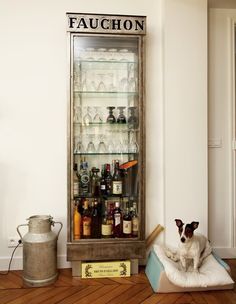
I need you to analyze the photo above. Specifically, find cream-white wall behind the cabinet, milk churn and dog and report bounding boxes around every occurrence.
[0,0,207,269]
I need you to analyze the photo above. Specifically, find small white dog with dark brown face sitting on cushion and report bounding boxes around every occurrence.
[167,219,212,272]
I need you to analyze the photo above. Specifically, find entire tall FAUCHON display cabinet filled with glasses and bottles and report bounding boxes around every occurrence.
[67,13,146,275]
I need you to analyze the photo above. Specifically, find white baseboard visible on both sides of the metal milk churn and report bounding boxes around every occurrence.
[0,255,71,271]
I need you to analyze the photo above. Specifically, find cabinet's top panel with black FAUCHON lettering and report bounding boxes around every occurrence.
[67,13,146,35]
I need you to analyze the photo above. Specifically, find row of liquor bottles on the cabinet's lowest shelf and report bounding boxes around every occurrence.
[73,198,139,240]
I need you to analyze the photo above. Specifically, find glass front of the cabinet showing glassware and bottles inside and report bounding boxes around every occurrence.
[70,34,143,242]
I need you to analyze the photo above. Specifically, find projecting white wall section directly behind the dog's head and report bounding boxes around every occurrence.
[164,0,208,244]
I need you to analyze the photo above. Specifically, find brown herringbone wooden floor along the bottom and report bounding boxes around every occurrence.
[0,260,236,304]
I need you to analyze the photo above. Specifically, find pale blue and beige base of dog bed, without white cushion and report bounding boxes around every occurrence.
[145,249,234,293]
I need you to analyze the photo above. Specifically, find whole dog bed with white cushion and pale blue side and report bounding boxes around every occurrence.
[145,245,234,293]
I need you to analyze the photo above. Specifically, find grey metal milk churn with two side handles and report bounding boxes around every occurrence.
[17,215,63,287]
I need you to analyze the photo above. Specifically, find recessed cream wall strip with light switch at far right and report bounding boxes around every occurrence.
[209,9,236,257]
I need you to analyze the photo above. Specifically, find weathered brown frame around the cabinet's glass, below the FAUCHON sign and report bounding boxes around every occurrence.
[67,14,146,268]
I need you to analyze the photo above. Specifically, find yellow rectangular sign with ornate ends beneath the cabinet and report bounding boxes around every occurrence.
[82,261,130,279]
